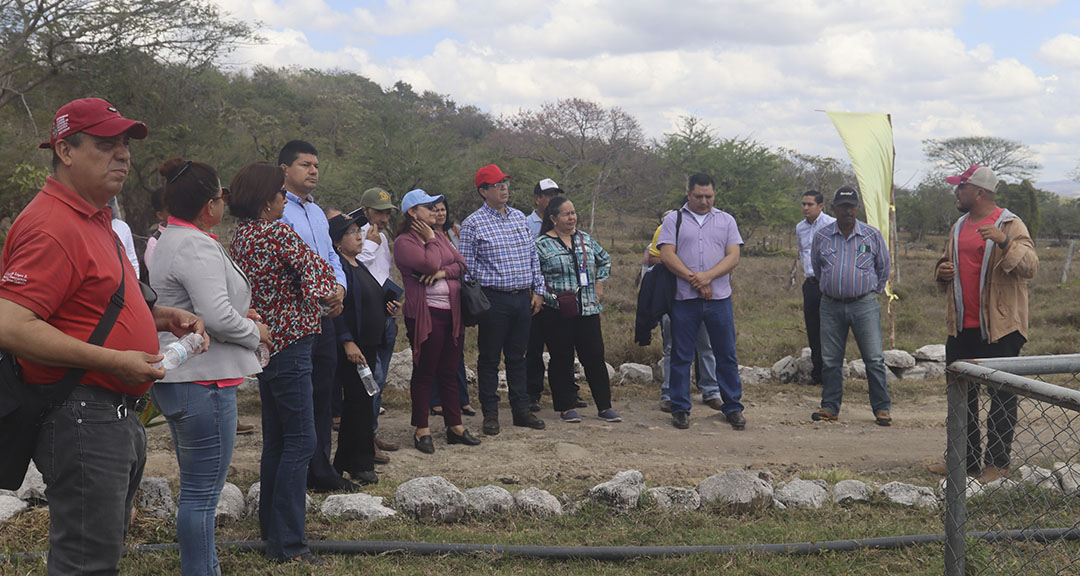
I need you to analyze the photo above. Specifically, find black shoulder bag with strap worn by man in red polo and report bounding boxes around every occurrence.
[0,235,126,490]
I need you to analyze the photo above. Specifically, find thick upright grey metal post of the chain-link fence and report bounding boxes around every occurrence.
[945,373,968,576]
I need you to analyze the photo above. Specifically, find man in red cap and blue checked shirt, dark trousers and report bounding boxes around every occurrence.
[459,164,544,436]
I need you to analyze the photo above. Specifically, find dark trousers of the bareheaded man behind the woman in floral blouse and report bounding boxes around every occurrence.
[308,318,341,485]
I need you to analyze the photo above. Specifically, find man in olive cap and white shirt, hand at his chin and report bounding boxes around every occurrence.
[356,188,399,464]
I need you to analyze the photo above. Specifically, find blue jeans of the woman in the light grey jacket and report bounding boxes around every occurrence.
[150,383,237,576]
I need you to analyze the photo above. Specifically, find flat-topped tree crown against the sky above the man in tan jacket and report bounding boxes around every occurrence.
[922,136,1042,180]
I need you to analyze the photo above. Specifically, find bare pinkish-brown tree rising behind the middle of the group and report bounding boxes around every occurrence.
[501,98,645,231]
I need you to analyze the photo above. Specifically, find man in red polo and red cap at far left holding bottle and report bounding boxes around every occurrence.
[0,98,205,574]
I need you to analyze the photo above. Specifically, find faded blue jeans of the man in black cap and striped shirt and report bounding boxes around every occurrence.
[821,292,892,414]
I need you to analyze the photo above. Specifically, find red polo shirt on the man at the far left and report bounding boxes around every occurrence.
[0,177,158,396]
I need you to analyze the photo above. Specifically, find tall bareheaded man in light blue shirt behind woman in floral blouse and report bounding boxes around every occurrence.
[278,140,360,492]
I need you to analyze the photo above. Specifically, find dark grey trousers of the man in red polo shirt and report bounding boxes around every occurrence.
[33,385,146,575]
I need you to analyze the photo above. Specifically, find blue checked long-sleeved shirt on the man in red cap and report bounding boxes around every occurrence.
[458,202,545,296]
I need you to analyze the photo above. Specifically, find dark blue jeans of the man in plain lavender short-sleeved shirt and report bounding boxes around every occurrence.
[669,298,743,414]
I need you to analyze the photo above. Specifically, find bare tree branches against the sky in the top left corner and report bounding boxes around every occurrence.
[0,0,259,106]
